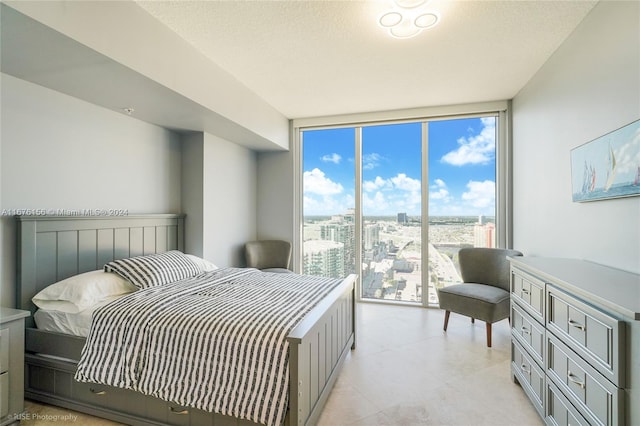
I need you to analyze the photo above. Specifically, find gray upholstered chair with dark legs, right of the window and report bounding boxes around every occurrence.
[437,247,522,347]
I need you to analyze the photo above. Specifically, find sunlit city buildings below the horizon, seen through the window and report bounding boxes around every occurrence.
[303,212,495,304]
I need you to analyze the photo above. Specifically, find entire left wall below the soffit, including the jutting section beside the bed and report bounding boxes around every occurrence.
[0,74,257,307]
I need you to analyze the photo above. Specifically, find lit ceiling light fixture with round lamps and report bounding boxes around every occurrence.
[378,0,440,38]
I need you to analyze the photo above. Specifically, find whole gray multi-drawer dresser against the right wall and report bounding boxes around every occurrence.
[510,257,640,425]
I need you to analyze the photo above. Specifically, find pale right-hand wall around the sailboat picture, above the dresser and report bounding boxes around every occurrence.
[513,1,640,272]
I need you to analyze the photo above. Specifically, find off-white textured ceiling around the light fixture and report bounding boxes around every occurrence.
[138,0,597,118]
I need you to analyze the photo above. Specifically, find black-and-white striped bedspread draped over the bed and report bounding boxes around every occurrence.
[75,268,341,425]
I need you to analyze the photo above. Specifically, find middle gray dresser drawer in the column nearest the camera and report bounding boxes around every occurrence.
[546,333,624,426]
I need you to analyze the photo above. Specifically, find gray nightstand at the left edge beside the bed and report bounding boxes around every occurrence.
[0,308,31,426]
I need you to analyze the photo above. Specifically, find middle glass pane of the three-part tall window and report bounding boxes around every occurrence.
[361,123,422,303]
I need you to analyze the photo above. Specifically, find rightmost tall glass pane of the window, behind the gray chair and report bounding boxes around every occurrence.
[428,117,497,304]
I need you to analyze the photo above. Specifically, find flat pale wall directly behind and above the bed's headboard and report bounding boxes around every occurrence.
[0,74,181,307]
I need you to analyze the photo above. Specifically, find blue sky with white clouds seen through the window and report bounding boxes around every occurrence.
[302,117,496,216]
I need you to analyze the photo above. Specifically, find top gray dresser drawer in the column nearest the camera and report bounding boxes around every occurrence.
[547,285,625,387]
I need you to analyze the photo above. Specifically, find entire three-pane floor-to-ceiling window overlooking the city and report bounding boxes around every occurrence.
[297,105,506,305]
